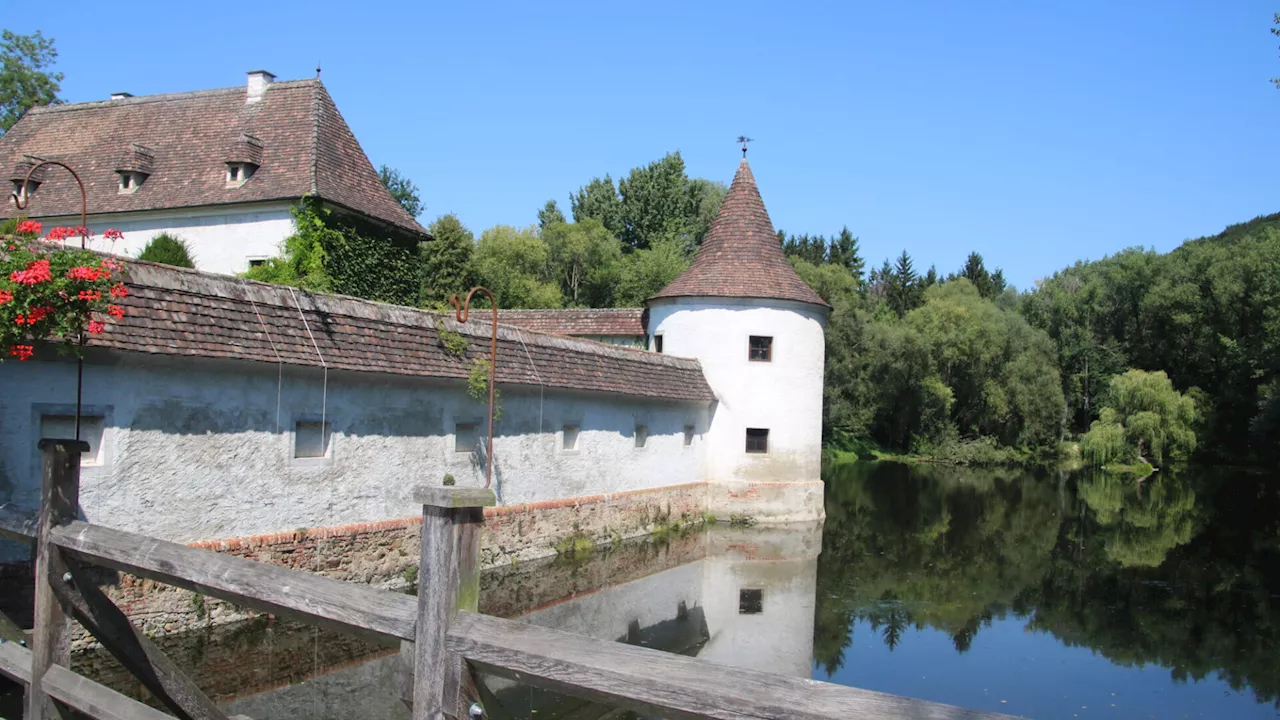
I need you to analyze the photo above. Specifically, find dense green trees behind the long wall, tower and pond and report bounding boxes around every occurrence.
[241,152,1280,465]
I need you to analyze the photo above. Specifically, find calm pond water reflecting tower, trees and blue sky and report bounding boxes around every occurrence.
[15,464,1280,720]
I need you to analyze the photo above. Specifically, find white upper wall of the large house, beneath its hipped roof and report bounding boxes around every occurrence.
[41,202,293,274]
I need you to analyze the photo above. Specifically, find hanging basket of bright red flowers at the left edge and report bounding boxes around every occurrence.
[0,220,129,361]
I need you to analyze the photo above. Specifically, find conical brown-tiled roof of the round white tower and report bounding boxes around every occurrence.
[650,158,831,307]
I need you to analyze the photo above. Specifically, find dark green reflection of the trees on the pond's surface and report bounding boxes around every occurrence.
[814,464,1280,701]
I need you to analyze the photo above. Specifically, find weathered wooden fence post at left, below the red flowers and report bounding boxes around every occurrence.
[26,439,88,720]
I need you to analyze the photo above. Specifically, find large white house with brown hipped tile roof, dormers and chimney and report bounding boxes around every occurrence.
[0,70,428,274]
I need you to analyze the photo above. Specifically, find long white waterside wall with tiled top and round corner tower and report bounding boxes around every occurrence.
[0,155,828,560]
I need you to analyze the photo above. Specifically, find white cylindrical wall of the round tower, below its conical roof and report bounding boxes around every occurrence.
[649,297,827,482]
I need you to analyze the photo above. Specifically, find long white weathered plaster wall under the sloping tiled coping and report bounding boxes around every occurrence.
[0,354,708,561]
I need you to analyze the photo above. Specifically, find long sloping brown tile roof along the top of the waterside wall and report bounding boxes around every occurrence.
[88,260,716,402]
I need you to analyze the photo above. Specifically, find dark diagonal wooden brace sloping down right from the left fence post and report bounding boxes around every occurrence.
[49,560,227,720]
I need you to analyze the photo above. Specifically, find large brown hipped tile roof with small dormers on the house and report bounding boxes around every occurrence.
[0,79,426,234]
